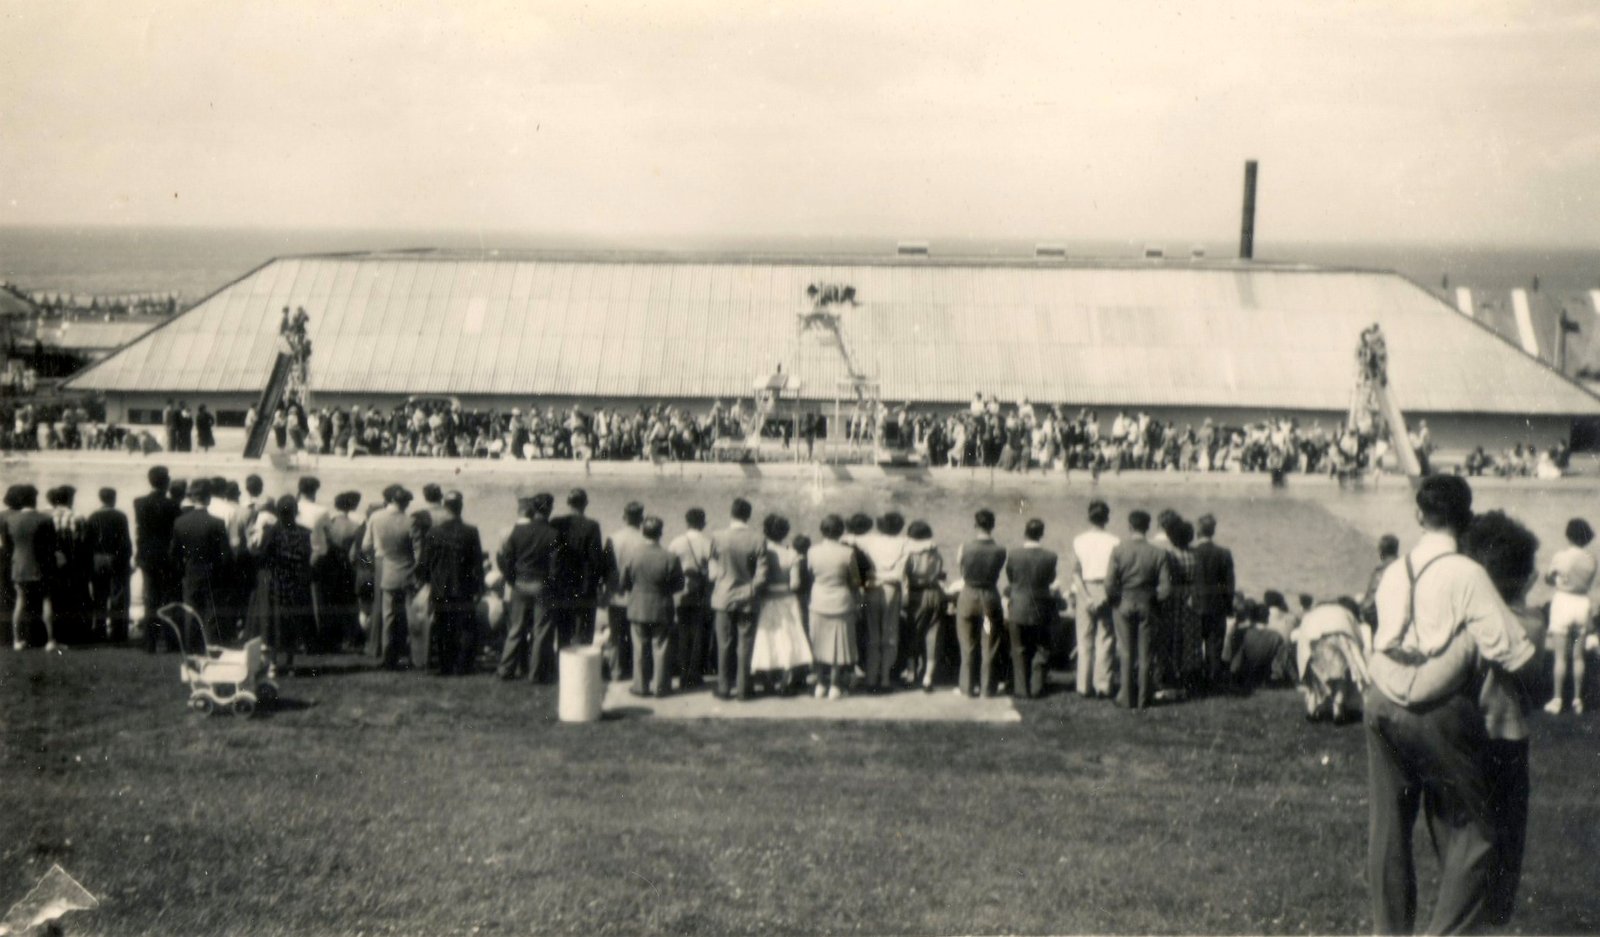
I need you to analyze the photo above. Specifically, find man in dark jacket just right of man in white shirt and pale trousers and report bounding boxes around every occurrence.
[1106,510,1173,710]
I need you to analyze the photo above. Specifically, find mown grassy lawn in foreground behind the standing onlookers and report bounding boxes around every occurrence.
[0,649,1600,934]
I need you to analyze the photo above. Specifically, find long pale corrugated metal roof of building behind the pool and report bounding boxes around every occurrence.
[59,253,1600,414]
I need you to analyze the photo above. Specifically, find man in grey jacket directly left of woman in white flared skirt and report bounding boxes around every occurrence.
[710,497,766,700]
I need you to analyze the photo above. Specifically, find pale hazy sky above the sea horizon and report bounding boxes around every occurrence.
[0,0,1600,246]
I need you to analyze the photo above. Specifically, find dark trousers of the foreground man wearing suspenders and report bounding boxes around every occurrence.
[1365,689,1494,934]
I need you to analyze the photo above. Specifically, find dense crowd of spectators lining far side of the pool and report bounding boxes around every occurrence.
[0,386,1571,478]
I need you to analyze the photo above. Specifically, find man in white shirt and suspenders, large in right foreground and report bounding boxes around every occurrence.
[1365,475,1536,934]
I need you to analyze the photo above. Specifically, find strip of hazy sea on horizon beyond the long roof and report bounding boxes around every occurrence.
[0,227,1600,302]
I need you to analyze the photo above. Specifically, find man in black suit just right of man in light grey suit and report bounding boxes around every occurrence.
[418,491,483,676]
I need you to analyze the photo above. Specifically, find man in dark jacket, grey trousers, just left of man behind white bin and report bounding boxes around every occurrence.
[496,492,555,683]
